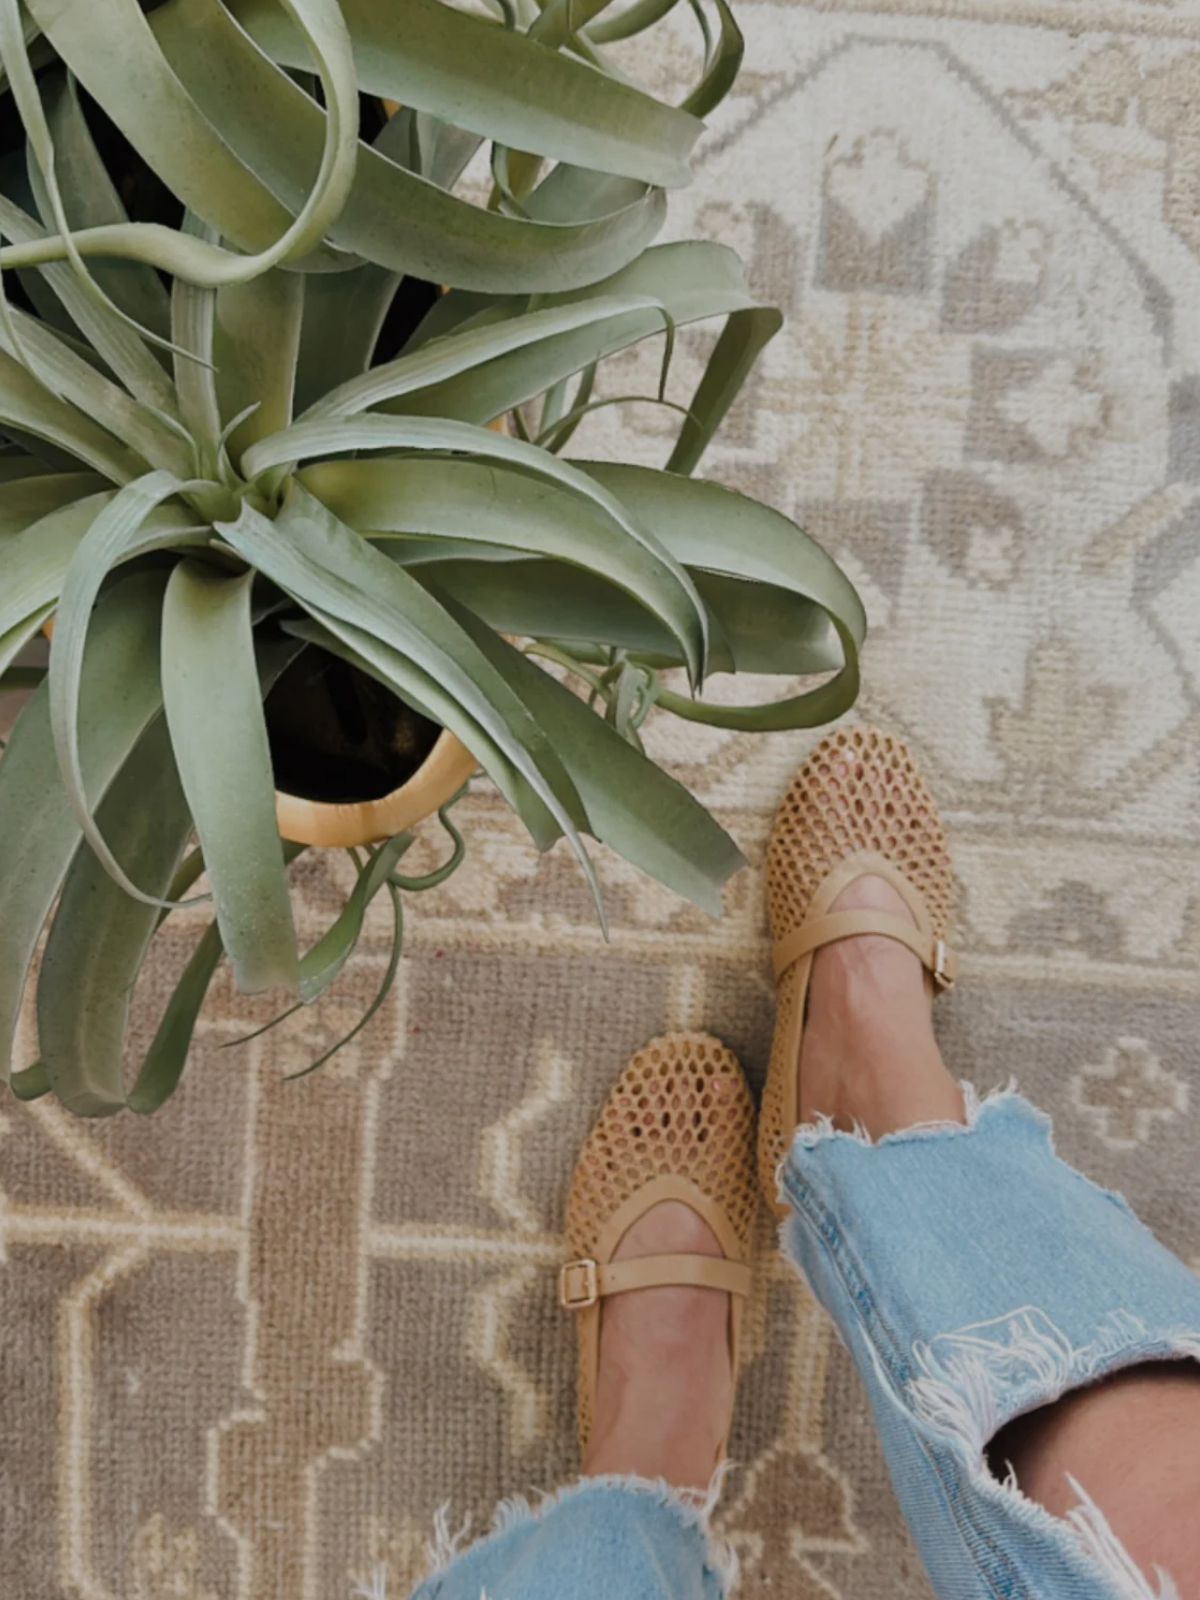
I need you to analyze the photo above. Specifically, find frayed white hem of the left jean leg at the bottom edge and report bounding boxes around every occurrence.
[350,1461,738,1600]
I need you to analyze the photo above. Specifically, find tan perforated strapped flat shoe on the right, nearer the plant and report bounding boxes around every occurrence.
[758,728,958,1216]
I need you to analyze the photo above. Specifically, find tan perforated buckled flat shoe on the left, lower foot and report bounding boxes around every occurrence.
[558,1034,758,1459]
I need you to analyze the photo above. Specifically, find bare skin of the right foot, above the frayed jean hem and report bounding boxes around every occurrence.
[800,877,965,1139]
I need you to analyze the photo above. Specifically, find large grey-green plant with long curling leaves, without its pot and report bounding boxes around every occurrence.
[0,0,864,1115]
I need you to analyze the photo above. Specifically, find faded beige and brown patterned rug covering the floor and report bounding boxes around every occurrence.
[0,0,1200,1600]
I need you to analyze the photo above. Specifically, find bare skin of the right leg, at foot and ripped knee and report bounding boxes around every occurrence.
[800,878,1200,1592]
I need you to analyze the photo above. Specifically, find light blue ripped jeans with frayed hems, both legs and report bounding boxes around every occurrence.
[392,1085,1200,1600]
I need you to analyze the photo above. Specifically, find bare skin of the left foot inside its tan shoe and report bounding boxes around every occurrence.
[584,1078,733,1488]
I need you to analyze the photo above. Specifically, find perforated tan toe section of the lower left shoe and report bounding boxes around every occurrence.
[566,1034,758,1256]
